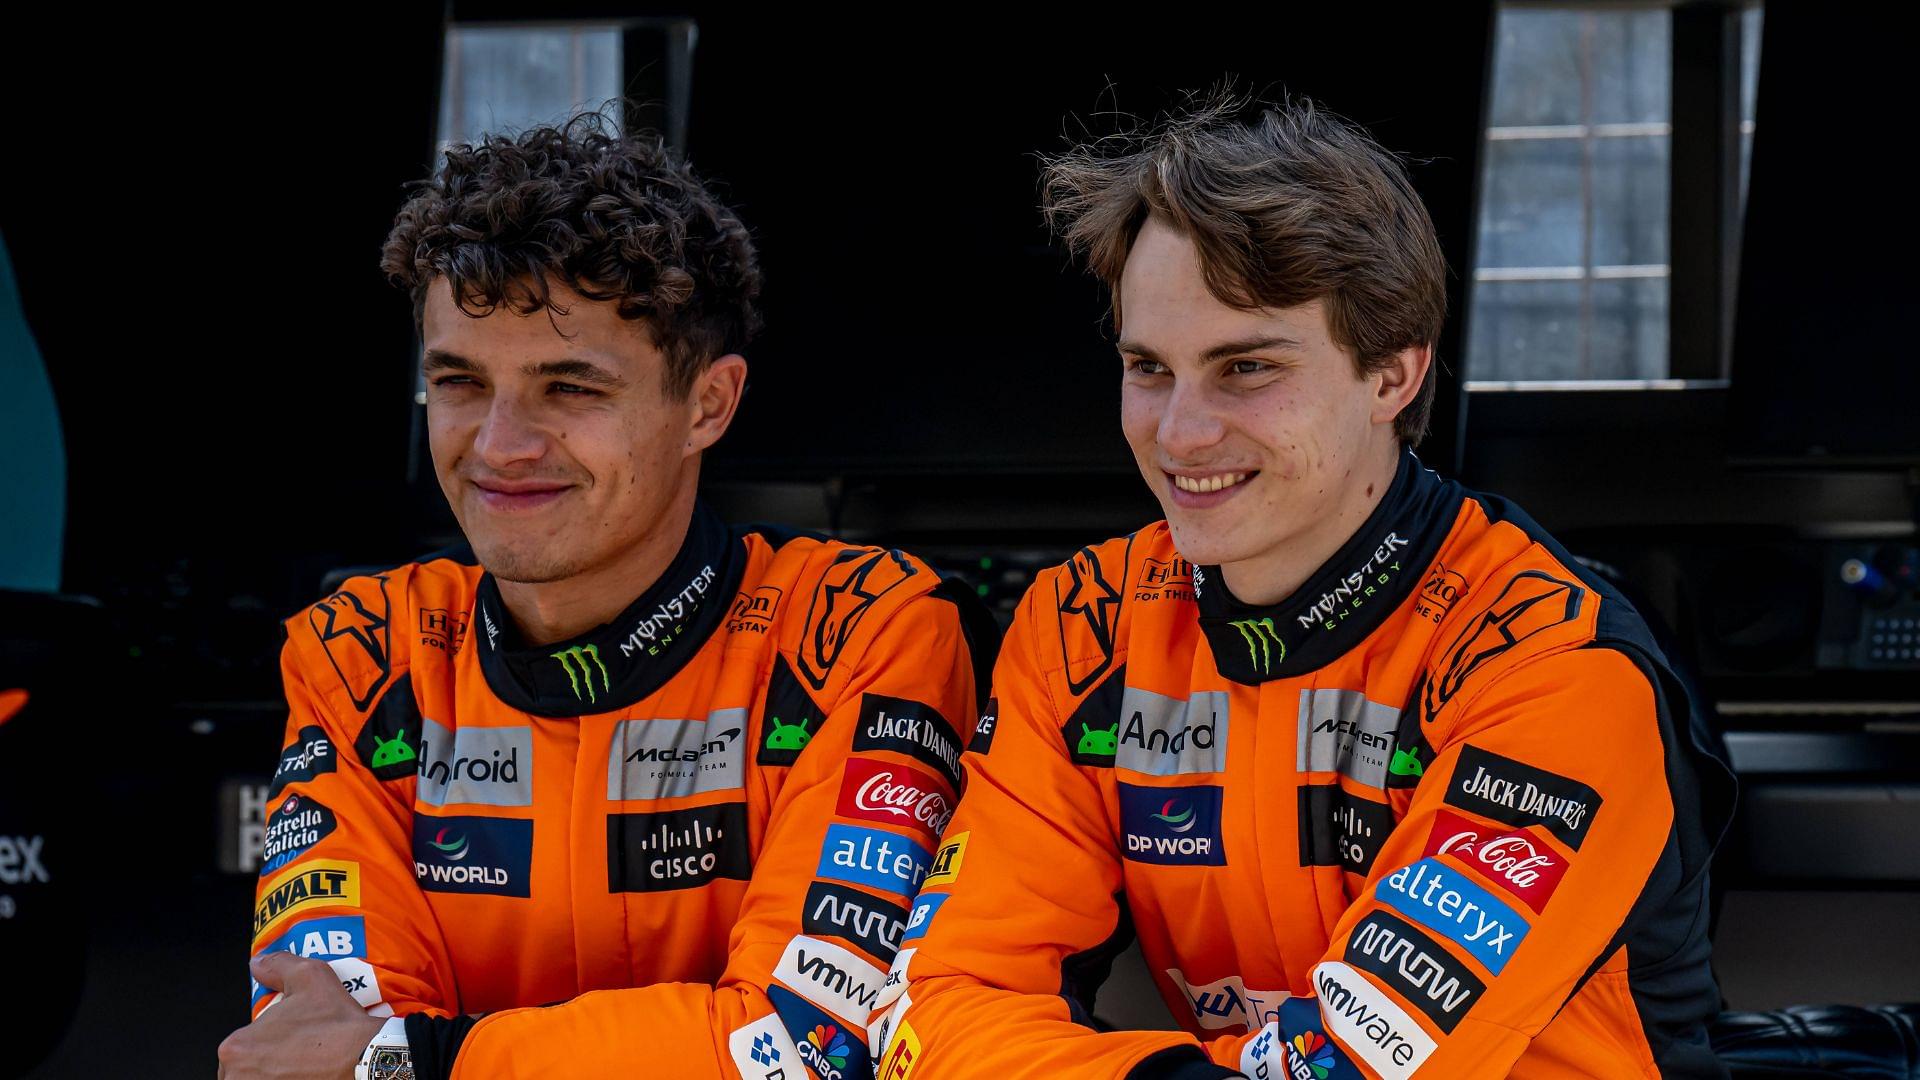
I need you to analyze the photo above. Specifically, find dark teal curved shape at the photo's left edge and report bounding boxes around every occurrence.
[0,232,67,592]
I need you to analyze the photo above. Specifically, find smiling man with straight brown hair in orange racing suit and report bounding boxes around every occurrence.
[874,100,1732,1080]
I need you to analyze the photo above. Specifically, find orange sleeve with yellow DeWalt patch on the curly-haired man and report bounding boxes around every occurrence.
[252,578,459,1017]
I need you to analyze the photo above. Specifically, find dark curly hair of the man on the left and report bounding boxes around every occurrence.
[380,113,760,398]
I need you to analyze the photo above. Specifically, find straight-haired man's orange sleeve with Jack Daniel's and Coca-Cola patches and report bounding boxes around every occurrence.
[1210,648,1678,1080]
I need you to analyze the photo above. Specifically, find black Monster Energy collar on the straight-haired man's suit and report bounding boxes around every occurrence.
[1194,452,1459,684]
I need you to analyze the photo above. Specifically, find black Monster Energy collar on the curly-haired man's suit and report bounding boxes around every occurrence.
[472,503,747,717]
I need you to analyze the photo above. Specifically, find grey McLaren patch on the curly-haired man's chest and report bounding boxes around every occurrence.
[607,709,747,801]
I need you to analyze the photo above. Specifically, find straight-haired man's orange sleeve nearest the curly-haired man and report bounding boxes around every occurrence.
[876,578,1227,1080]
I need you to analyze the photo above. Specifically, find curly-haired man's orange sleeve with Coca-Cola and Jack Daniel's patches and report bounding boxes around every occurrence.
[451,596,977,1080]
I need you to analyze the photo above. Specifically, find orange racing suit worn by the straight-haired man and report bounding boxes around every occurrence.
[872,454,1732,1080]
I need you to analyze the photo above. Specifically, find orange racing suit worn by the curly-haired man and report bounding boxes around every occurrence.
[253,507,991,1080]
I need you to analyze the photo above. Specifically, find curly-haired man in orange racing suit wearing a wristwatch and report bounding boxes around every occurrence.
[221,115,991,1080]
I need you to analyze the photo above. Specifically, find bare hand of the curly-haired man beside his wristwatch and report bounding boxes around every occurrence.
[219,951,386,1080]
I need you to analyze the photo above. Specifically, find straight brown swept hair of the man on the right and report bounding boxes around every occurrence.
[1043,86,1446,446]
